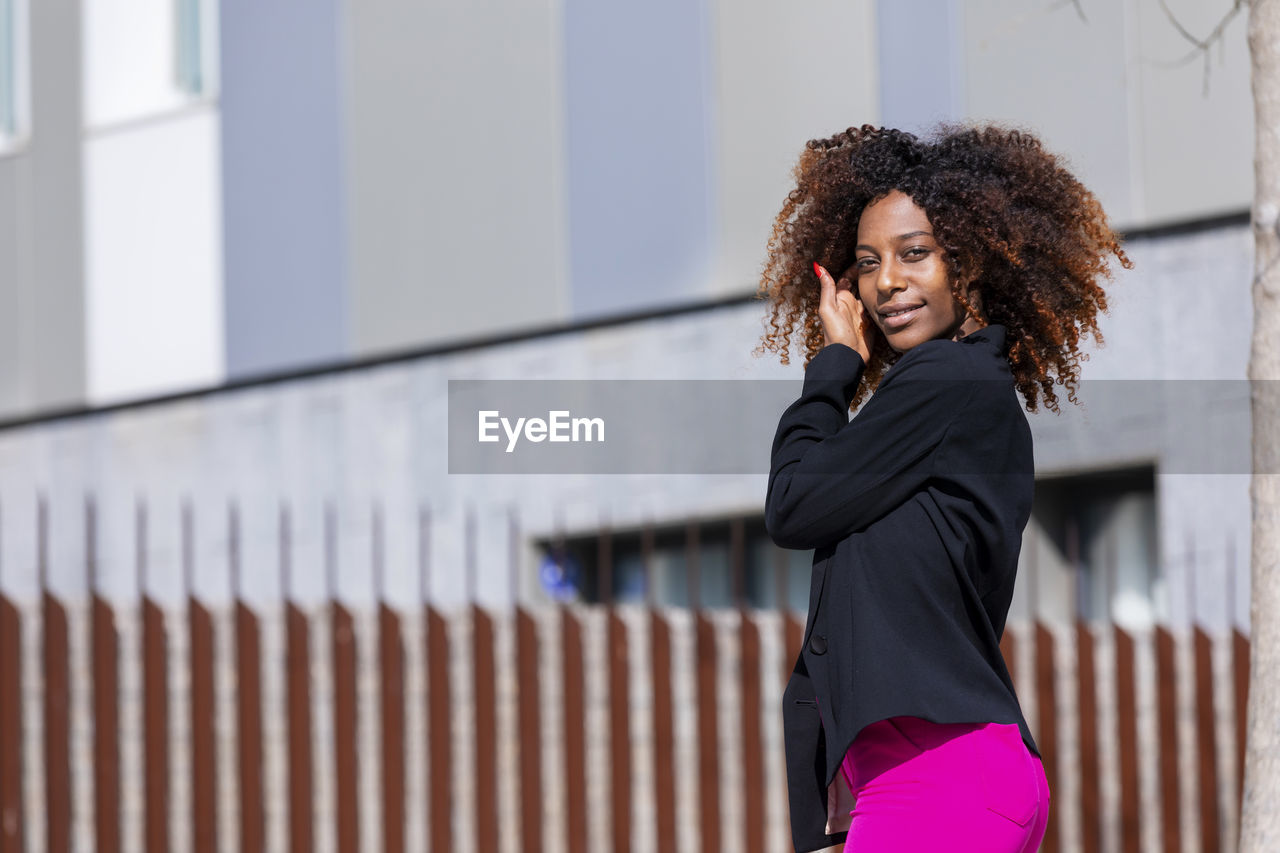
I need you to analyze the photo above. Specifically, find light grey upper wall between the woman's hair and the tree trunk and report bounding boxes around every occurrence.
[961,0,1253,228]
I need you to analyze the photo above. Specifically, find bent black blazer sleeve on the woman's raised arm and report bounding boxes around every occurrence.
[764,341,973,549]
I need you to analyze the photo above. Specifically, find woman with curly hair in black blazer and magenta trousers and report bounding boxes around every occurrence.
[758,126,1132,853]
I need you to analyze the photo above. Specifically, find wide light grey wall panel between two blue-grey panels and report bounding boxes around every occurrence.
[344,0,568,355]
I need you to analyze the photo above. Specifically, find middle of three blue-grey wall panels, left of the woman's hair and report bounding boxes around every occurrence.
[564,0,718,319]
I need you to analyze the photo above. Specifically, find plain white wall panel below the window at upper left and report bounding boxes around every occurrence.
[84,109,225,405]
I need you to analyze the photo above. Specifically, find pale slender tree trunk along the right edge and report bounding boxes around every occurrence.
[1239,0,1280,853]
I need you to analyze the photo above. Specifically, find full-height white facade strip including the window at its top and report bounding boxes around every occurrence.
[82,0,225,406]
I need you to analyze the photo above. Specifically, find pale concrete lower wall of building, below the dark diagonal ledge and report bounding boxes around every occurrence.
[0,227,1249,635]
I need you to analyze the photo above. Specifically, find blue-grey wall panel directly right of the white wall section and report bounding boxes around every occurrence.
[220,0,347,379]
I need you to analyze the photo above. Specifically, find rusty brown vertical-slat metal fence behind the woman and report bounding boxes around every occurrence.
[0,494,1249,853]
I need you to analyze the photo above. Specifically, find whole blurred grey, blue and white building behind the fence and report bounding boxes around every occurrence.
[0,0,1252,624]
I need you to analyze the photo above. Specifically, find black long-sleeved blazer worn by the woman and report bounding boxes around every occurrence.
[765,324,1039,853]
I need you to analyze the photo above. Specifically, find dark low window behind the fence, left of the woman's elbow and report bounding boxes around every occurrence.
[539,516,813,612]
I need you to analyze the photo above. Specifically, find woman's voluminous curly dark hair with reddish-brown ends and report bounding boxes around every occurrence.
[755,124,1133,411]
